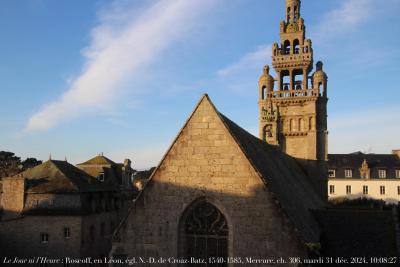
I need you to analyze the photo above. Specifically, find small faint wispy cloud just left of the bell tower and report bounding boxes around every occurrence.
[217,45,272,77]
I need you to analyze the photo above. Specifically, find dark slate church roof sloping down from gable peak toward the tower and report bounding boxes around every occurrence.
[115,94,324,245]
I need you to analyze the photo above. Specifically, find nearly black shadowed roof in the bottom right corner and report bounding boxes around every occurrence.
[314,208,397,260]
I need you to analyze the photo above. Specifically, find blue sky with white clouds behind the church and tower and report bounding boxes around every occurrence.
[0,0,400,168]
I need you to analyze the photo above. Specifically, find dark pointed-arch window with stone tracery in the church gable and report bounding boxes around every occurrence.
[178,200,229,266]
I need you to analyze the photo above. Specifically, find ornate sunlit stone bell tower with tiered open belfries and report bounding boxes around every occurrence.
[258,0,328,199]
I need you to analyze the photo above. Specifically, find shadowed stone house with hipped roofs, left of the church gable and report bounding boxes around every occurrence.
[0,156,133,263]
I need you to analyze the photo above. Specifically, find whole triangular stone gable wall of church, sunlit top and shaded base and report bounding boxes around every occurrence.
[111,95,316,257]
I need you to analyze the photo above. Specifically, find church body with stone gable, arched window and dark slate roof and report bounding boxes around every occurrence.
[112,95,323,266]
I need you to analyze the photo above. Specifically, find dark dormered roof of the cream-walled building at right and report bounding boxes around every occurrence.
[328,152,400,169]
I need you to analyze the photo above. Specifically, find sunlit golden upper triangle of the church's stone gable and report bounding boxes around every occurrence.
[151,95,263,197]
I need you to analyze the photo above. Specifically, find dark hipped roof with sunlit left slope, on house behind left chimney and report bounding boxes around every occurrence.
[21,160,110,193]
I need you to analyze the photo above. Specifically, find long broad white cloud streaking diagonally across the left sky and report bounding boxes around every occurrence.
[25,0,212,131]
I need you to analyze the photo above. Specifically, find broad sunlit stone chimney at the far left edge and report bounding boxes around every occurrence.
[0,176,25,219]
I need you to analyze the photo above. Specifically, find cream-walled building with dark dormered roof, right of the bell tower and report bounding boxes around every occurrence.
[328,150,400,203]
